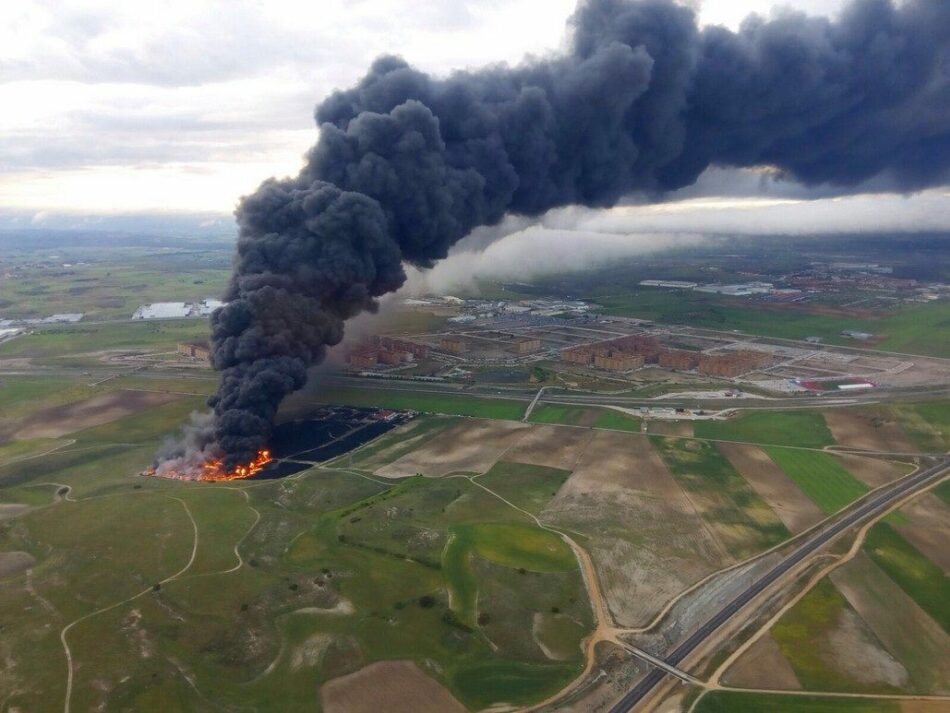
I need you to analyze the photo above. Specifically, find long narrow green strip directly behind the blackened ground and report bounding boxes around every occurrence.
[313,387,528,421]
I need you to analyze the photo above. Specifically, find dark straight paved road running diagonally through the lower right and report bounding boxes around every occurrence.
[610,459,950,713]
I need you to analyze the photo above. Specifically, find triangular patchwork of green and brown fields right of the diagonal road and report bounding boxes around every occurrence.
[714,470,950,710]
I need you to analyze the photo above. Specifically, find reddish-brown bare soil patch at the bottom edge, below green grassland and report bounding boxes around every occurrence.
[320,661,465,713]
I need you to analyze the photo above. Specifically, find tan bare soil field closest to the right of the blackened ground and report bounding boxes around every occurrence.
[375,419,530,478]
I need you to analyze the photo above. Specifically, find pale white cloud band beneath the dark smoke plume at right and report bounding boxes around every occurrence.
[408,189,950,296]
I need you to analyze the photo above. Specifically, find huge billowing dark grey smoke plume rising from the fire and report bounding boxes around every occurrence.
[190,0,950,465]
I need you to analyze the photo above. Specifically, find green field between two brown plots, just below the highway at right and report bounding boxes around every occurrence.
[693,411,834,448]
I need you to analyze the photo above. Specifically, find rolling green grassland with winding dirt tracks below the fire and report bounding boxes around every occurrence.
[0,356,592,713]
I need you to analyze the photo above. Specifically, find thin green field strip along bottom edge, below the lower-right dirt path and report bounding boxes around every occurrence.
[693,691,901,713]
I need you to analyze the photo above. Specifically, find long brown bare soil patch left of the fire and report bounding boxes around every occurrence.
[14,391,181,438]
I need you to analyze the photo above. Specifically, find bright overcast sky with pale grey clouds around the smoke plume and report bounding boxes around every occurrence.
[0,0,950,245]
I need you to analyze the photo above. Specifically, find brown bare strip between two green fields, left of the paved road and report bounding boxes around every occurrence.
[716,443,824,533]
